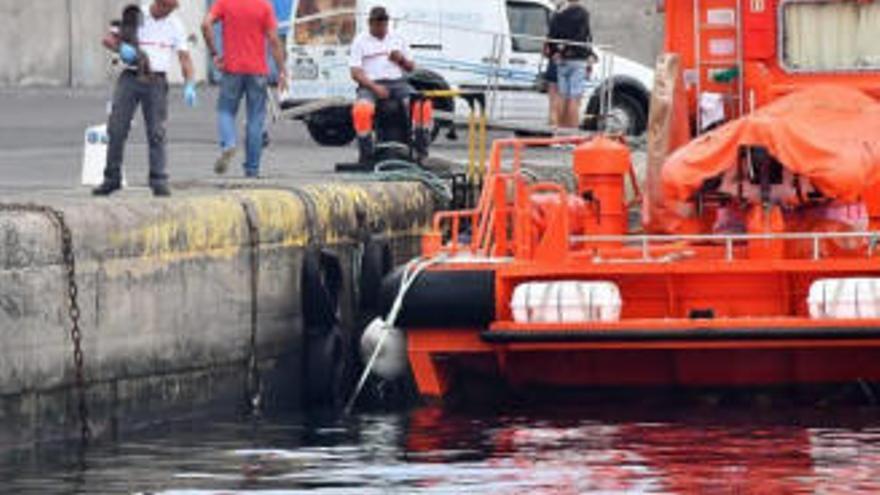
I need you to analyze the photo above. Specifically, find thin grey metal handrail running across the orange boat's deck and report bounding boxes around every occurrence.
[569,231,880,261]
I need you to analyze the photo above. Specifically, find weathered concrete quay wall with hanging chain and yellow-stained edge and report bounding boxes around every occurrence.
[0,183,433,448]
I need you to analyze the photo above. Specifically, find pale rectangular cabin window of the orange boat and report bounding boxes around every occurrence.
[781,0,880,72]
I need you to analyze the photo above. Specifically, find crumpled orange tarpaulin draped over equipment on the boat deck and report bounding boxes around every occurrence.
[663,85,880,204]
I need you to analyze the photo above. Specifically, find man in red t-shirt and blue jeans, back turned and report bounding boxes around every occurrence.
[202,0,287,177]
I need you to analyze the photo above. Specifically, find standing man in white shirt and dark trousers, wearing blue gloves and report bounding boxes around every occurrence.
[92,0,196,196]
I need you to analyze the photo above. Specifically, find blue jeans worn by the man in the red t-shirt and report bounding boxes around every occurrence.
[217,73,267,175]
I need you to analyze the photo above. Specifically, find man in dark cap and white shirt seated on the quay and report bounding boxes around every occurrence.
[349,7,415,161]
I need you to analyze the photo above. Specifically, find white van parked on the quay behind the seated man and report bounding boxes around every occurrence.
[285,0,654,145]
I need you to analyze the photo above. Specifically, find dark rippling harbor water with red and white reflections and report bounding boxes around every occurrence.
[0,401,880,495]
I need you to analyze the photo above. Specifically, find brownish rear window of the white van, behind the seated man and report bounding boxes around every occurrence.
[294,0,357,45]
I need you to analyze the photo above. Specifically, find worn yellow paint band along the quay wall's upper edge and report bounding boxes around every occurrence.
[109,183,428,266]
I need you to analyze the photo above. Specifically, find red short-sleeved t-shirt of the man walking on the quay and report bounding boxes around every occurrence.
[211,0,278,75]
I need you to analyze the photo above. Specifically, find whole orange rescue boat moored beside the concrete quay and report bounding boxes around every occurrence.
[386,0,880,397]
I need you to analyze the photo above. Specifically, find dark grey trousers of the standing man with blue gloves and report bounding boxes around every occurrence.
[104,71,168,186]
